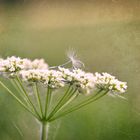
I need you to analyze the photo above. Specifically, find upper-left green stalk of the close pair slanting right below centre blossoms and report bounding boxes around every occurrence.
[47,86,73,120]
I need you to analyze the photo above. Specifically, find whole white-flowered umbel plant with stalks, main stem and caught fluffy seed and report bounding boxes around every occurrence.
[0,54,127,140]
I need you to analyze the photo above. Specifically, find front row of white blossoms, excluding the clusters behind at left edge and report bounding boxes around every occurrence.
[19,67,127,94]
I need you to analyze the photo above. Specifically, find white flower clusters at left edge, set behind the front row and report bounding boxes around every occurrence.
[0,56,48,75]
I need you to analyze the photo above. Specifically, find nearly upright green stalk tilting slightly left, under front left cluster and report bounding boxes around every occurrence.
[35,83,43,117]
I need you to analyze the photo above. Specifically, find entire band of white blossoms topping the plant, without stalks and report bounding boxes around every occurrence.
[0,56,127,93]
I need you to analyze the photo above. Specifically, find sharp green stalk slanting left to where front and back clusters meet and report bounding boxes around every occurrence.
[16,76,41,119]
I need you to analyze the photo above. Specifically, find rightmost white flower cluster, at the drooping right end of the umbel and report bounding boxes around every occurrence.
[95,72,127,93]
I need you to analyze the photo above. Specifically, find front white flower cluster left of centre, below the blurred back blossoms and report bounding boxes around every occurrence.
[19,69,64,88]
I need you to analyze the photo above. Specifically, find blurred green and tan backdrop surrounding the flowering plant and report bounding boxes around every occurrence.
[0,0,140,140]
